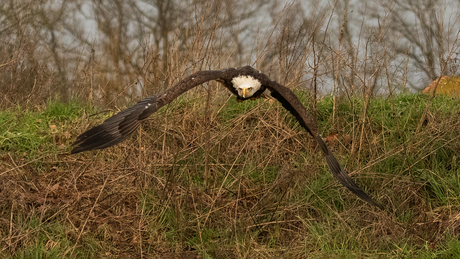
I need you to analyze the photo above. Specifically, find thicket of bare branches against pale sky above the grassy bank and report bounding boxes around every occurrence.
[0,0,460,107]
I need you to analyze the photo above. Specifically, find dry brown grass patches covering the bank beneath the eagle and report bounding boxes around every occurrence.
[0,94,460,258]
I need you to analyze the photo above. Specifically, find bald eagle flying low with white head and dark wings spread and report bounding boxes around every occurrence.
[71,66,383,209]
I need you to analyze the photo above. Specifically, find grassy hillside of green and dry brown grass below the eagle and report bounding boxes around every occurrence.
[0,92,460,258]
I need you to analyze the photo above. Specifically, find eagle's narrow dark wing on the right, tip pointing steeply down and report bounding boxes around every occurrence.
[262,78,383,210]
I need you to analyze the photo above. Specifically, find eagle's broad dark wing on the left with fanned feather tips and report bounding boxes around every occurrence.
[71,70,225,154]
